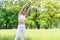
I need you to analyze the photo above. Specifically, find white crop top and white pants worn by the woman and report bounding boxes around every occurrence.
[14,15,25,40]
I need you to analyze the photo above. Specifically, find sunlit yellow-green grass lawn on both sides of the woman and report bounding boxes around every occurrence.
[0,29,60,40]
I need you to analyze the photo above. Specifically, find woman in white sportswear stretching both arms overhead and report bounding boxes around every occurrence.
[14,3,31,40]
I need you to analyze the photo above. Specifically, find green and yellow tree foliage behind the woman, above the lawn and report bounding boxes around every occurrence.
[0,0,60,29]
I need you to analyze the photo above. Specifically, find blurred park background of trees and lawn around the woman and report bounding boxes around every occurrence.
[0,0,60,40]
